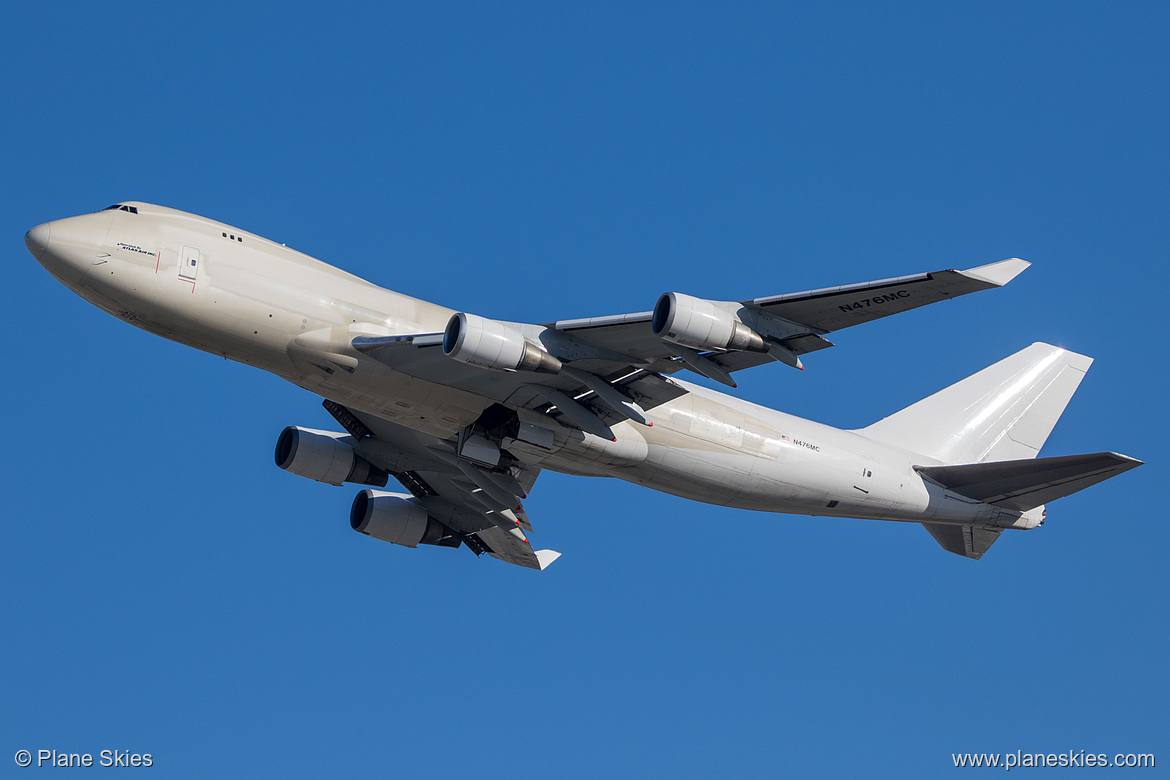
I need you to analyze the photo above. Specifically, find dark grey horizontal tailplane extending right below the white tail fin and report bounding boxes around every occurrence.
[915,453,1142,512]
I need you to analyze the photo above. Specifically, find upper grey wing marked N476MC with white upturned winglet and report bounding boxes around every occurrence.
[351,258,1028,439]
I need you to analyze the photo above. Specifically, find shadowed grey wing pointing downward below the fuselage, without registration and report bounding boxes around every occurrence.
[324,400,560,570]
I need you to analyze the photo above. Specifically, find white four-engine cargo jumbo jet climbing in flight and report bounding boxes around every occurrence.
[25,201,1141,570]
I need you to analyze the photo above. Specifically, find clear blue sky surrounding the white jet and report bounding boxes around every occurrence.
[0,2,1170,778]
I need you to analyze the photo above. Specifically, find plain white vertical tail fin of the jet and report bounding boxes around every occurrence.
[860,344,1093,463]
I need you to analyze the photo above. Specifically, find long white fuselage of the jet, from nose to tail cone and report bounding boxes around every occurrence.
[27,203,1035,537]
